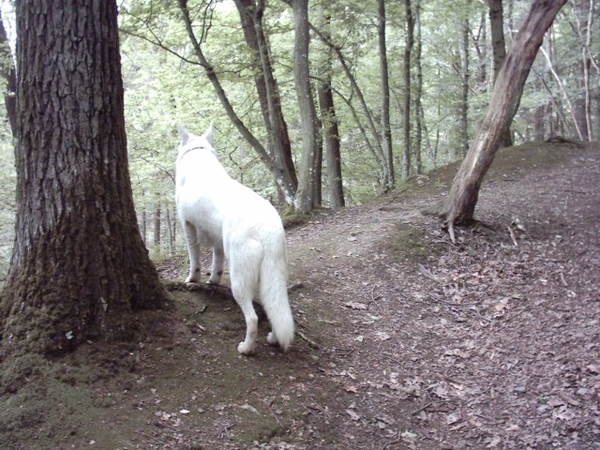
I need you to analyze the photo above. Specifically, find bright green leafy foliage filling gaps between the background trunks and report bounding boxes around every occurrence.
[0,0,600,260]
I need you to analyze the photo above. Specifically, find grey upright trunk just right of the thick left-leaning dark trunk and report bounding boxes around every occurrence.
[292,0,320,214]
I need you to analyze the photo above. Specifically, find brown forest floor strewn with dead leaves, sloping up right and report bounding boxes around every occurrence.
[0,139,600,450]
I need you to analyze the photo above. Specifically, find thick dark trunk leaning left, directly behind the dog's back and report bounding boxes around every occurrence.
[235,0,298,197]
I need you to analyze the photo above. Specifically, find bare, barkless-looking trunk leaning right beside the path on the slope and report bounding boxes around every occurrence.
[439,0,566,239]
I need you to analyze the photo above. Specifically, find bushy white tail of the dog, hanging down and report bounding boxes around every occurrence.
[259,232,294,351]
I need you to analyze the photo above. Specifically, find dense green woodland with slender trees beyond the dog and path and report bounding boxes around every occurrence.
[0,0,600,272]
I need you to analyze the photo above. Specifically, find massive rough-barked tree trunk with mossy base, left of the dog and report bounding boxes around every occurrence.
[0,0,167,354]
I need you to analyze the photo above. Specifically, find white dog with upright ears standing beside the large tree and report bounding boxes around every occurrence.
[176,124,294,354]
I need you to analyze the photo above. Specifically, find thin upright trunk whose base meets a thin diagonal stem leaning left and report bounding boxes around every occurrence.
[377,0,395,191]
